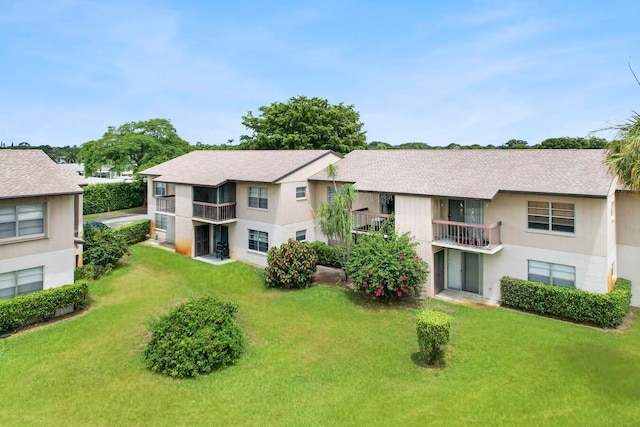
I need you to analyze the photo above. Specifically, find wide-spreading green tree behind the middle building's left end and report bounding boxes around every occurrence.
[80,119,191,175]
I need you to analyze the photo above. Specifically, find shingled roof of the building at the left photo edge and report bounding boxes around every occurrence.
[0,149,84,199]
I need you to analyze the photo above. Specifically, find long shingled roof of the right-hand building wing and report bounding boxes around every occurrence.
[311,149,613,200]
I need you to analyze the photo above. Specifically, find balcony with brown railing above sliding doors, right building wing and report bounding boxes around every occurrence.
[431,219,502,255]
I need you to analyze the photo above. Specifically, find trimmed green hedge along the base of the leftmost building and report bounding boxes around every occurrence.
[0,282,89,333]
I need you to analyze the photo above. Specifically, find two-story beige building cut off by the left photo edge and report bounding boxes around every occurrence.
[0,149,84,298]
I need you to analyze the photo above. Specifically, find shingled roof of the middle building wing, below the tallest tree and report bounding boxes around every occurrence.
[140,150,335,187]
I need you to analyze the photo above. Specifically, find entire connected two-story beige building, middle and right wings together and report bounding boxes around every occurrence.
[143,149,640,306]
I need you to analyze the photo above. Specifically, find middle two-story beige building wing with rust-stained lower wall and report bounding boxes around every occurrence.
[141,150,340,266]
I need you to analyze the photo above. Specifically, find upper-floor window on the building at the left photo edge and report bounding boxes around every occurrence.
[0,203,45,239]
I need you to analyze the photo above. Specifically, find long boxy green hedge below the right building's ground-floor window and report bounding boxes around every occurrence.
[500,277,631,328]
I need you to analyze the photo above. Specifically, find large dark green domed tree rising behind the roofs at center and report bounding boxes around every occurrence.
[240,96,367,154]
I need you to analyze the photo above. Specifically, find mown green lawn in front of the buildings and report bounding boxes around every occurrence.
[0,246,640,426]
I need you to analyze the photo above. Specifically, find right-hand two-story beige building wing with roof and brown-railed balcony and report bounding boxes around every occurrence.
[310,149,640,306]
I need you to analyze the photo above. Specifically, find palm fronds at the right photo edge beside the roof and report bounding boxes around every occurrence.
[605,112,640,192]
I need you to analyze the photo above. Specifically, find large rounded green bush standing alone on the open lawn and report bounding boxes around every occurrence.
[144,297,245,378]
